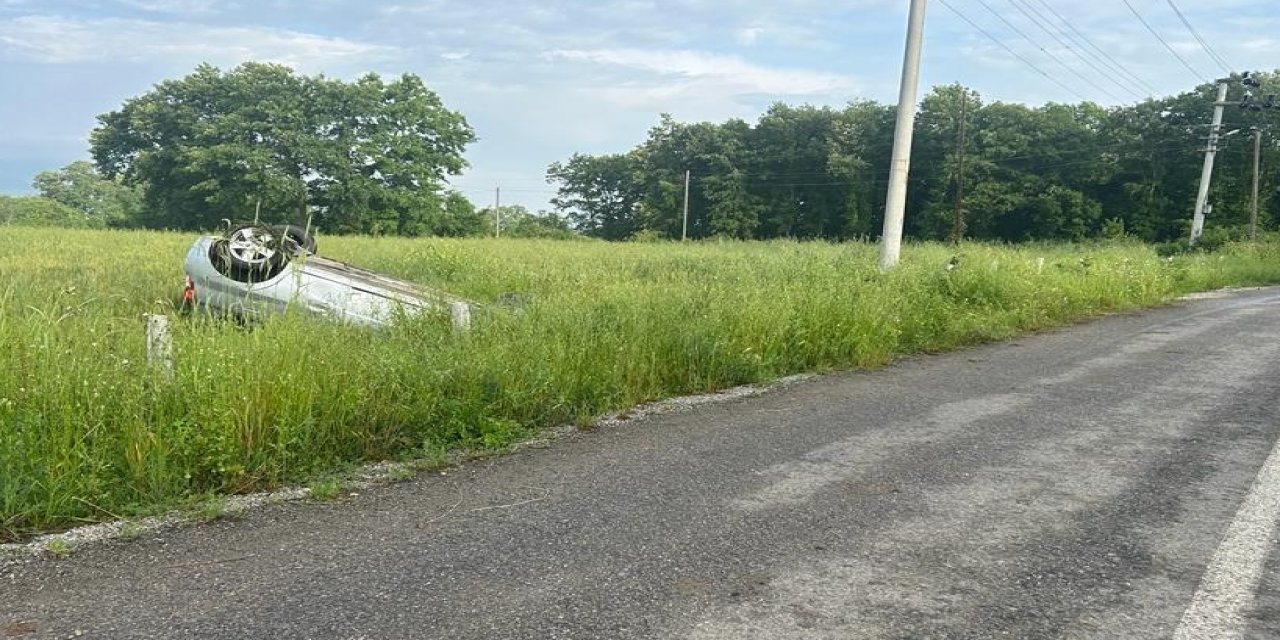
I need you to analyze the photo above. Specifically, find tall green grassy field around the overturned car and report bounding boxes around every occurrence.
[0,228,1280,540]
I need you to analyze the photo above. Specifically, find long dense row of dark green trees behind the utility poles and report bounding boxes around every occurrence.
[547,74,1280,242]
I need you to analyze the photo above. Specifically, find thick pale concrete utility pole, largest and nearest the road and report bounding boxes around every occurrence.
[881,0,924,270]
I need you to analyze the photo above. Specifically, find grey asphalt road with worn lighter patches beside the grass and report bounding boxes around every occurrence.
[0,289,1280,640]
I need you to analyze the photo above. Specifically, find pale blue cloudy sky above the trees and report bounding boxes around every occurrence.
[0,0,1280,210]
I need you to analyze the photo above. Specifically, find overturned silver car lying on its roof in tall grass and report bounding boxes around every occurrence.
[183,224,465,326]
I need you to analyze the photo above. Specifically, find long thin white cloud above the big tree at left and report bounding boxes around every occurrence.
[0,15,397,69]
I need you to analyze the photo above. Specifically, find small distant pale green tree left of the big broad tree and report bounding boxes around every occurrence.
[31,160,142,227]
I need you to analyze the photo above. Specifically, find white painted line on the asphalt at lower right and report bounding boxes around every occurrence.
[1174,432,1280,640]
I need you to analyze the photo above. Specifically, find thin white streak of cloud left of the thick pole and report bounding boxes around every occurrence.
[547,49,859,96]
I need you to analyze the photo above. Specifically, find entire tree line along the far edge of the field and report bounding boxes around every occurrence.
[0,63,1280,242]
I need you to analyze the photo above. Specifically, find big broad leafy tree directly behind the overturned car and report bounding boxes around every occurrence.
[90,63,475,233]
